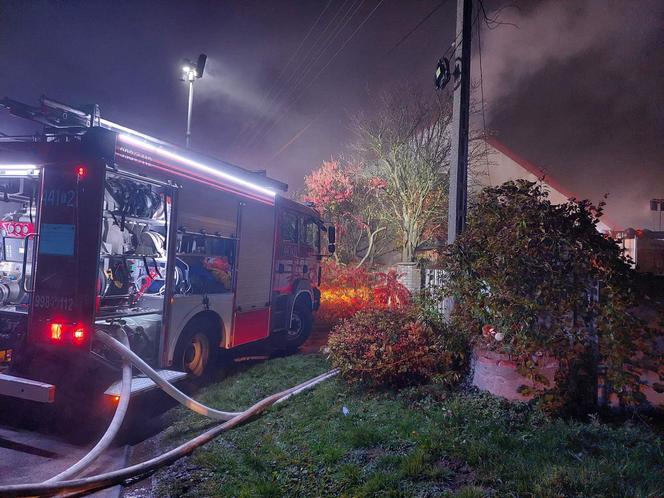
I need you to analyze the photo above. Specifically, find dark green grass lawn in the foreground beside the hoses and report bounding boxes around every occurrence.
[155,355,664,497]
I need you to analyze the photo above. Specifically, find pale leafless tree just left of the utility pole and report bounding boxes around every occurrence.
[354,92,452,261]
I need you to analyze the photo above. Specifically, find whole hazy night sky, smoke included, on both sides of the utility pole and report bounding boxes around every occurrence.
[0,0,664,228]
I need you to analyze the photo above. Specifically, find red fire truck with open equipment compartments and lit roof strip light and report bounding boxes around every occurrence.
[0,98,334,402]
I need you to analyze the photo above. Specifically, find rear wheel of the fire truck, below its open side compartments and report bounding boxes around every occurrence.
[173,320,219,377]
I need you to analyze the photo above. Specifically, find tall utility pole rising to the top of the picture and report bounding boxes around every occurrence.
[447,0,473,244]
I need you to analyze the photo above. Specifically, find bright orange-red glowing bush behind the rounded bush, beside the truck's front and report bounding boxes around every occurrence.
[317,261,410,326]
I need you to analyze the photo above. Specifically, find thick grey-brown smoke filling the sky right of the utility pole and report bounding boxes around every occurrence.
[473,0,664,228]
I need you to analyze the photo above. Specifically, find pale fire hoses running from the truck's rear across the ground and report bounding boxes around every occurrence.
[0,331,338,497]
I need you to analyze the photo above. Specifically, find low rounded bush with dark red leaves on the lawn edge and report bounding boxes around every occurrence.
[328,307,448,387]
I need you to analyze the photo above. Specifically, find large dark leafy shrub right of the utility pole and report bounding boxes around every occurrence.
[443,180,656,409]
